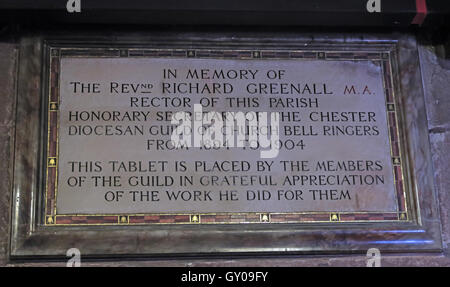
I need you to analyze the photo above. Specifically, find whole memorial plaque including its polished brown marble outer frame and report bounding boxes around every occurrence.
[11,33,442,259]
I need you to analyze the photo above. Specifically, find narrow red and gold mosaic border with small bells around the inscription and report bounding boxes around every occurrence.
[44,47,410,226]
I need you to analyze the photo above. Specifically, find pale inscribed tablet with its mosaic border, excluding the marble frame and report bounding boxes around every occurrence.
[45,47,408,225]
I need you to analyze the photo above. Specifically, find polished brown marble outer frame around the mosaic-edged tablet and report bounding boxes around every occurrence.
[10,33,441,259]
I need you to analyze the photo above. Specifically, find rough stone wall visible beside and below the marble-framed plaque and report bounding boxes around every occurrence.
[0,38,450,266]
